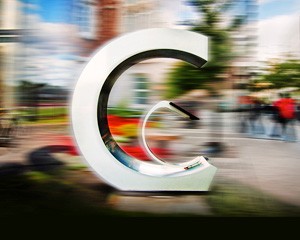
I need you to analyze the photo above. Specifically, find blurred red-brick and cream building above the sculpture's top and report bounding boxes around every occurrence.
[72,0,162,56]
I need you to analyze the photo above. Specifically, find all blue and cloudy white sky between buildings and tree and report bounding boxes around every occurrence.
[19,0,300,84]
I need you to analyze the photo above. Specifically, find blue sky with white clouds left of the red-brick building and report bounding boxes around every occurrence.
[19,0,80,88]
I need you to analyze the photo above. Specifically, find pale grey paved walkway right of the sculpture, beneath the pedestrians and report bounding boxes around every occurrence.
[169,113,300,206]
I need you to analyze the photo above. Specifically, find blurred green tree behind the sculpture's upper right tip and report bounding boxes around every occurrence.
[167,0,246,98]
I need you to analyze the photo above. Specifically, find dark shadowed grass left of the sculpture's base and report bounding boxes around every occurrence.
[0,168,182,217]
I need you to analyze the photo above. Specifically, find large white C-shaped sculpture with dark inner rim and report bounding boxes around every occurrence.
[71,28,217,191]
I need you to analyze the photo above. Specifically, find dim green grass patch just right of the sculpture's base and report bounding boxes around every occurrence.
[207,182,300,217]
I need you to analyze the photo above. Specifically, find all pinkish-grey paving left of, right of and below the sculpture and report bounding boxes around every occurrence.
[0,115,300,216]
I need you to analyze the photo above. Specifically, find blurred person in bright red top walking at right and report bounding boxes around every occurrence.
[270,93,296,140]
